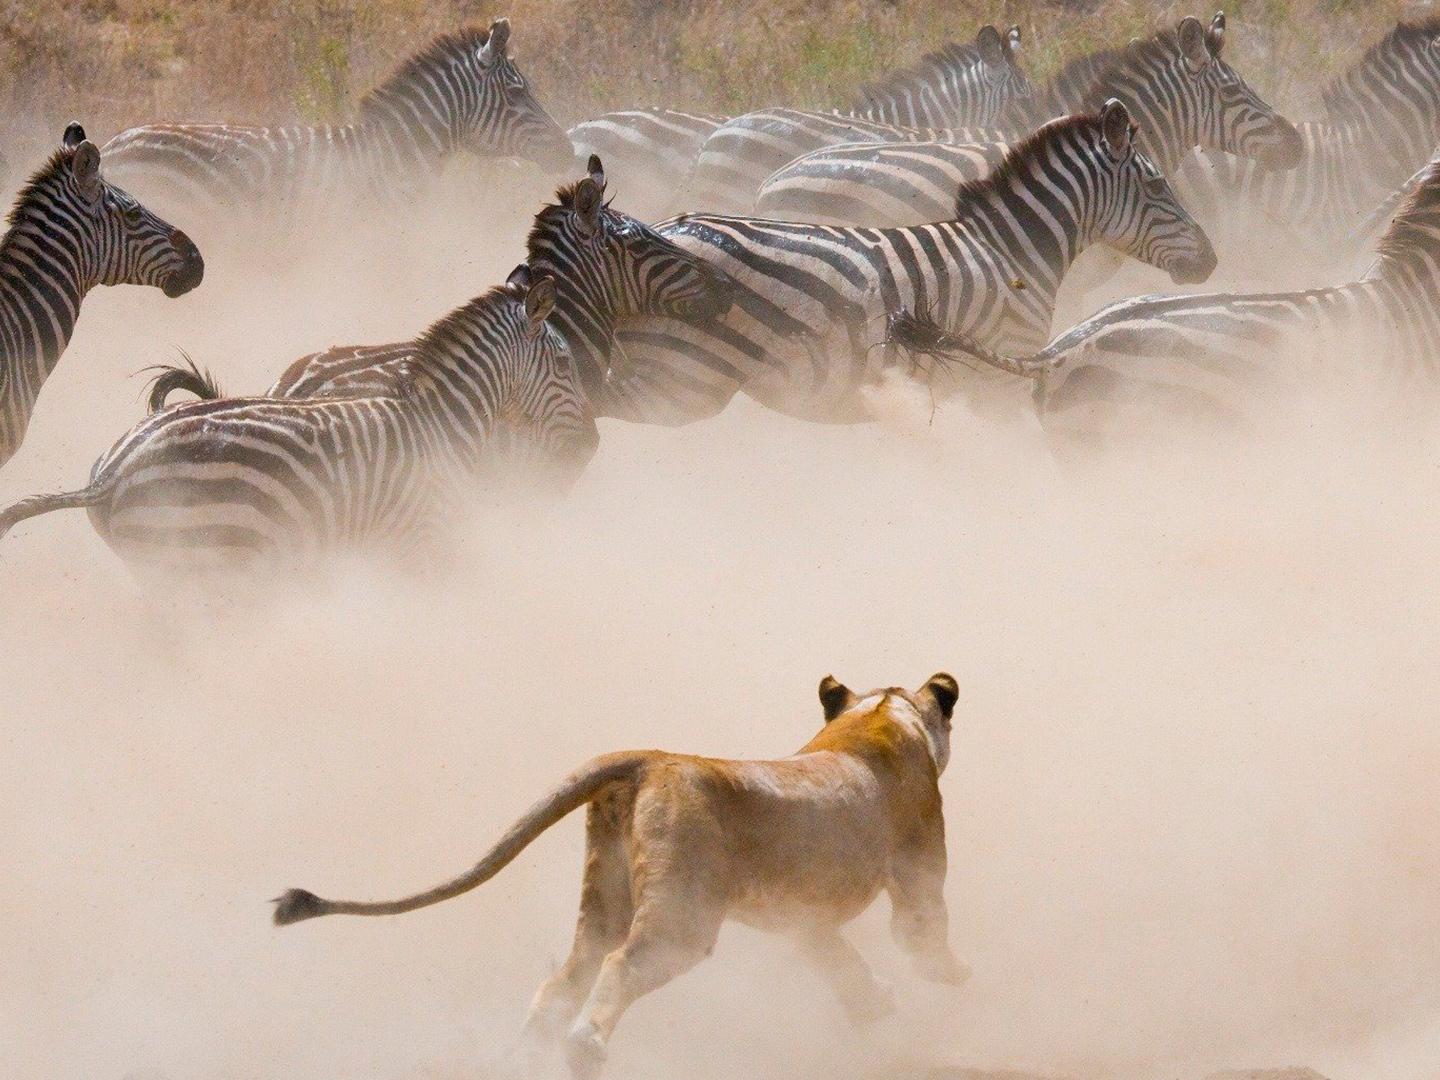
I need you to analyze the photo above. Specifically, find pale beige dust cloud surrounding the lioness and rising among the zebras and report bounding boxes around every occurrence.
[0,158,1440,1080]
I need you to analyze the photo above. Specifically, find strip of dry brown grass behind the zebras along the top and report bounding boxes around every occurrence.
[0,0,1405,157]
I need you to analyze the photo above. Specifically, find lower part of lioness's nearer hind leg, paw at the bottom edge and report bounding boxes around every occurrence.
[566,896,724,1080]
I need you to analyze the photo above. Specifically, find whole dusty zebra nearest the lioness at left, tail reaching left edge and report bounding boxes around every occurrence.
[0,266,598,573]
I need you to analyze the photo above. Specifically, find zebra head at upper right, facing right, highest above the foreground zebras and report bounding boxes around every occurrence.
[1172,12,1305,170]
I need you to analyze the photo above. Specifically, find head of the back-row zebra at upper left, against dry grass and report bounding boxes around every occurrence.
[455,19,575,173]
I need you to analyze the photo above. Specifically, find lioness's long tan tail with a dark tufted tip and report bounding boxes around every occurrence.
[272,753,645,926]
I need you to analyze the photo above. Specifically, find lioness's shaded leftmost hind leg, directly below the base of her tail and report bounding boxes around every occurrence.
[526,796,635,1041]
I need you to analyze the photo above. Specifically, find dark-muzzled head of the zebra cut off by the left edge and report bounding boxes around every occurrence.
[55,124,204,298]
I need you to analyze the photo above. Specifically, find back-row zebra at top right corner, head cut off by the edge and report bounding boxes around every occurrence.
[1175,17,1440,279]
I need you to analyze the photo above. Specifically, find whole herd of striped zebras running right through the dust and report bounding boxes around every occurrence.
[0,14,1440,570]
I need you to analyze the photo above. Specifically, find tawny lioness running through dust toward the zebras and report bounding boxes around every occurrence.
[275,674,966,1079]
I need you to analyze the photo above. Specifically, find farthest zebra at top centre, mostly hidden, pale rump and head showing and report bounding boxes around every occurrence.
[570,26,1030,217]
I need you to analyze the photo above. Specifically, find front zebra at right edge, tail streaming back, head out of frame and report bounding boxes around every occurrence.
[910,158,1440,435]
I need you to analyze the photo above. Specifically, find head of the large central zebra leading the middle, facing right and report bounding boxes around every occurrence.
[1090,98,1215,285]
